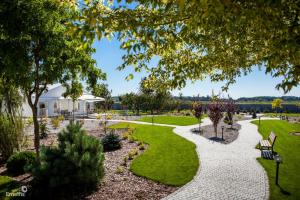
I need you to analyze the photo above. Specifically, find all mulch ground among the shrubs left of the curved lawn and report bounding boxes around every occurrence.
[0,120,178,200]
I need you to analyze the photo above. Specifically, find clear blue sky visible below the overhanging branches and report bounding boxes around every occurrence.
[93,39,300,98]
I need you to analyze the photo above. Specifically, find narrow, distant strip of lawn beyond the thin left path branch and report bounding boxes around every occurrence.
[138,115,198,126]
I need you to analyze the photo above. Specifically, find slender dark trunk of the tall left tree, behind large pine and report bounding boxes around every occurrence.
[32,105,40,163]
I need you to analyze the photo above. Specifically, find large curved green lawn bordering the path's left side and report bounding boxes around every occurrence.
[111,123,199,186]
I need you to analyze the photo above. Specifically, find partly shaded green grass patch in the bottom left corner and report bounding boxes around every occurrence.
[0,176,20,200]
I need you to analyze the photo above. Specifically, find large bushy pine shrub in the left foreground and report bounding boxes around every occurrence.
[31,122,104,193]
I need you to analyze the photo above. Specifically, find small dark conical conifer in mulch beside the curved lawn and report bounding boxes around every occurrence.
[102,129,121,151]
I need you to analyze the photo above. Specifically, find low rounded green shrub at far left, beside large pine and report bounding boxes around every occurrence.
[6,151,35,175]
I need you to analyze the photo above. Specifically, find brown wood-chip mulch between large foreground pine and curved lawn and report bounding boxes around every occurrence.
[86,140,178,200]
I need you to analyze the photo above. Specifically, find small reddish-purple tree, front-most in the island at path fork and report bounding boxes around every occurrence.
[208,100,224,137]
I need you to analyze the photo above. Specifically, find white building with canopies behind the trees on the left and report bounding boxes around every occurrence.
[23,85,105,117]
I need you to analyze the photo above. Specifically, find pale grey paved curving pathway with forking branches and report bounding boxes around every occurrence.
[108,119,269,200]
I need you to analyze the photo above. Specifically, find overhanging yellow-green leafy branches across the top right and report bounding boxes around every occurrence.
[81,0,300,92]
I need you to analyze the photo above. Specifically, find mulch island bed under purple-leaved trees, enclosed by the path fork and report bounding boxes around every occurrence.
[192,122,241,144]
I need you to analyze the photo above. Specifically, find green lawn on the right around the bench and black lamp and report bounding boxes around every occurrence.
[253,120,300,200]
